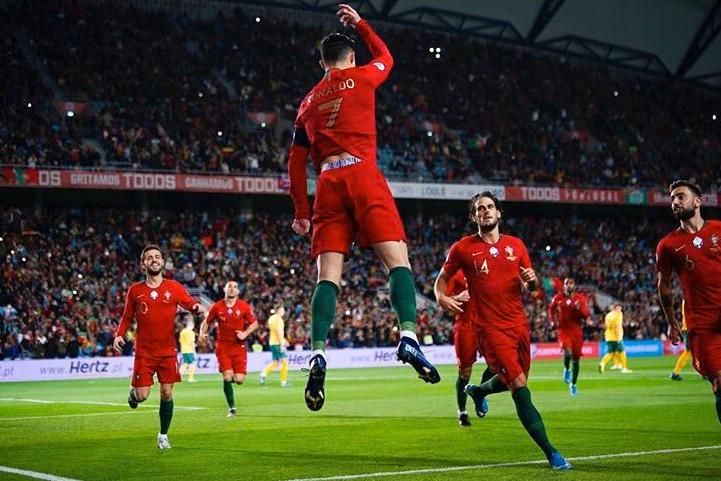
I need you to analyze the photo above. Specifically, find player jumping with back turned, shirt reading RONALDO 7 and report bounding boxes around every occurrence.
[288,4,440,411]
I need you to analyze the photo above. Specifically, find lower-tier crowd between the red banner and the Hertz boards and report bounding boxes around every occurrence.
[0,204,669,359]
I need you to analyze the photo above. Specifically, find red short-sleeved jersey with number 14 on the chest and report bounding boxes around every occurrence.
[443,234,531,331]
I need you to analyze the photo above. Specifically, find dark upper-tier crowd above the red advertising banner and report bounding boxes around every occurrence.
[0,1,721,190]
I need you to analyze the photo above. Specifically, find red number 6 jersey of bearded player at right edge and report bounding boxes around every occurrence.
[656,220,721,331]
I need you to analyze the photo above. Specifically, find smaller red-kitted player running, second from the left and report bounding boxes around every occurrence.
[199,281,258,418]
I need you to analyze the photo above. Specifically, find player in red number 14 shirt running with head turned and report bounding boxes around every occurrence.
[434,191,571,469]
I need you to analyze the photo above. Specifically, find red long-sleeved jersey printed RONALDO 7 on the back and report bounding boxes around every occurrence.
[288,20,393,219]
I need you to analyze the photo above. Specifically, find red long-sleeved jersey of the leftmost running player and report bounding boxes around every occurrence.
[115,279,198,357]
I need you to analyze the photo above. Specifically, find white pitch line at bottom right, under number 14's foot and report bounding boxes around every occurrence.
[288,445,721,481]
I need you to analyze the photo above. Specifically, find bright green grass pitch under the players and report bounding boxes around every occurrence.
[0,357,721,481]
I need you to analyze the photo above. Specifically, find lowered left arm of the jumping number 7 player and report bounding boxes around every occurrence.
[288,125,310,235]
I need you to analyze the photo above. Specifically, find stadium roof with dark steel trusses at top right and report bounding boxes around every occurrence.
[239,0,721,89]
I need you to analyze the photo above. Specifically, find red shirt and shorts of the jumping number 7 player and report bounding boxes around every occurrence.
[288,20,406,257]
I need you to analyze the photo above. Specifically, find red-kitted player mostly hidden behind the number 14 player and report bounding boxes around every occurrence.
[446,269,495,427]
